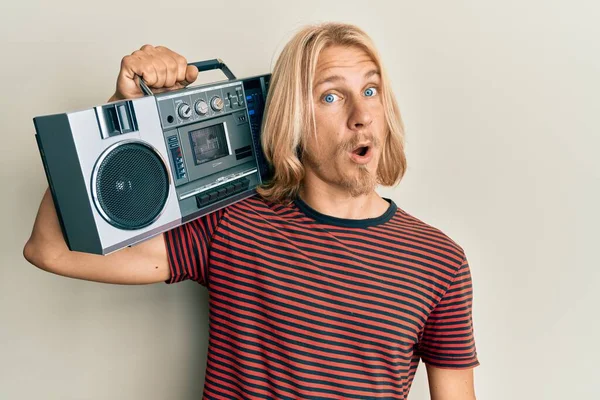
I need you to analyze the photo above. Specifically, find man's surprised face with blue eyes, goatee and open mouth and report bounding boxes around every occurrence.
[303,46,386,197]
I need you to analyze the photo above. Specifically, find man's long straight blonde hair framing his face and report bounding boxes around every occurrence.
[257,22,406,202]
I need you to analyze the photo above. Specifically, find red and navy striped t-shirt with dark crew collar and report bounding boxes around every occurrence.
[165,196,479,400]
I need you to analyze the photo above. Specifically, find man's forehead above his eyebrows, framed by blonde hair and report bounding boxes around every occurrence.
[315,46,377,81]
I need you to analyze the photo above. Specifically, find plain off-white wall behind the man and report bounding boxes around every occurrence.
[0,0,600,400]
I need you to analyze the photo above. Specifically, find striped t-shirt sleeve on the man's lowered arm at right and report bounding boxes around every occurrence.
[419,258,479,369]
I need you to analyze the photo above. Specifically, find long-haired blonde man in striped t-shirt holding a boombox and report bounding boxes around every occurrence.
[24,24,478,400]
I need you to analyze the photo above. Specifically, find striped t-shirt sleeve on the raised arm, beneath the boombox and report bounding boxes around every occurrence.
[163,209,225,286]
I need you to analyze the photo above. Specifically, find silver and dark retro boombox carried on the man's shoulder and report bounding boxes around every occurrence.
[33,59,270,254]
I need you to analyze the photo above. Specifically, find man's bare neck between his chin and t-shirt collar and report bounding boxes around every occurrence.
[300,181,389,219]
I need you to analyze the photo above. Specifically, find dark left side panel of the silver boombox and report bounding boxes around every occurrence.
[34,114,102,254]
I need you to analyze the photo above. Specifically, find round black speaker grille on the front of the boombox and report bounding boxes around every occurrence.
[96,142,169,230]
